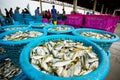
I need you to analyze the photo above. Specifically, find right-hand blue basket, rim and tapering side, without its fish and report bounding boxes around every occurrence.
[73,28,119,52]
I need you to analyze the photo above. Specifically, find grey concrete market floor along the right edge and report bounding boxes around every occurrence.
[105,23,120,80]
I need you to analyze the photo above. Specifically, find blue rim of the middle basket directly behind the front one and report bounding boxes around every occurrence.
[44,24,74,34]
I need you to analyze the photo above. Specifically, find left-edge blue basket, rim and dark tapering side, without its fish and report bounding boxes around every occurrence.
[0,29,47,65]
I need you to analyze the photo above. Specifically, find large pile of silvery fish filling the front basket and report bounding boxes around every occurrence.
[30,40,99,77]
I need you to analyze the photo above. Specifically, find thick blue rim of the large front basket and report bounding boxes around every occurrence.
[20,35,110,80]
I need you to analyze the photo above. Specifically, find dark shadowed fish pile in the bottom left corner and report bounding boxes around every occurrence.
[0,58,21,80]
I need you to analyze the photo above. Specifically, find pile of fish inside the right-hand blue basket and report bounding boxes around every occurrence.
[80,32,114,39]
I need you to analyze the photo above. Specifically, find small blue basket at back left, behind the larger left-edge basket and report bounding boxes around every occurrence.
[1,24,31,31]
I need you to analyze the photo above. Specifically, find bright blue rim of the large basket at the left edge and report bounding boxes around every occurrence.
[0,29,47,45]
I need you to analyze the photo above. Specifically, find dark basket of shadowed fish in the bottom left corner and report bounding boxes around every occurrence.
[0,57,28,80]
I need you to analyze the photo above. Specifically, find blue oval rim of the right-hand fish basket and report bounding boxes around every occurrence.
[72,28,119,43]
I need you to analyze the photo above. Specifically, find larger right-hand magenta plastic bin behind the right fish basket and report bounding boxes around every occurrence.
[84,15,118,33]
